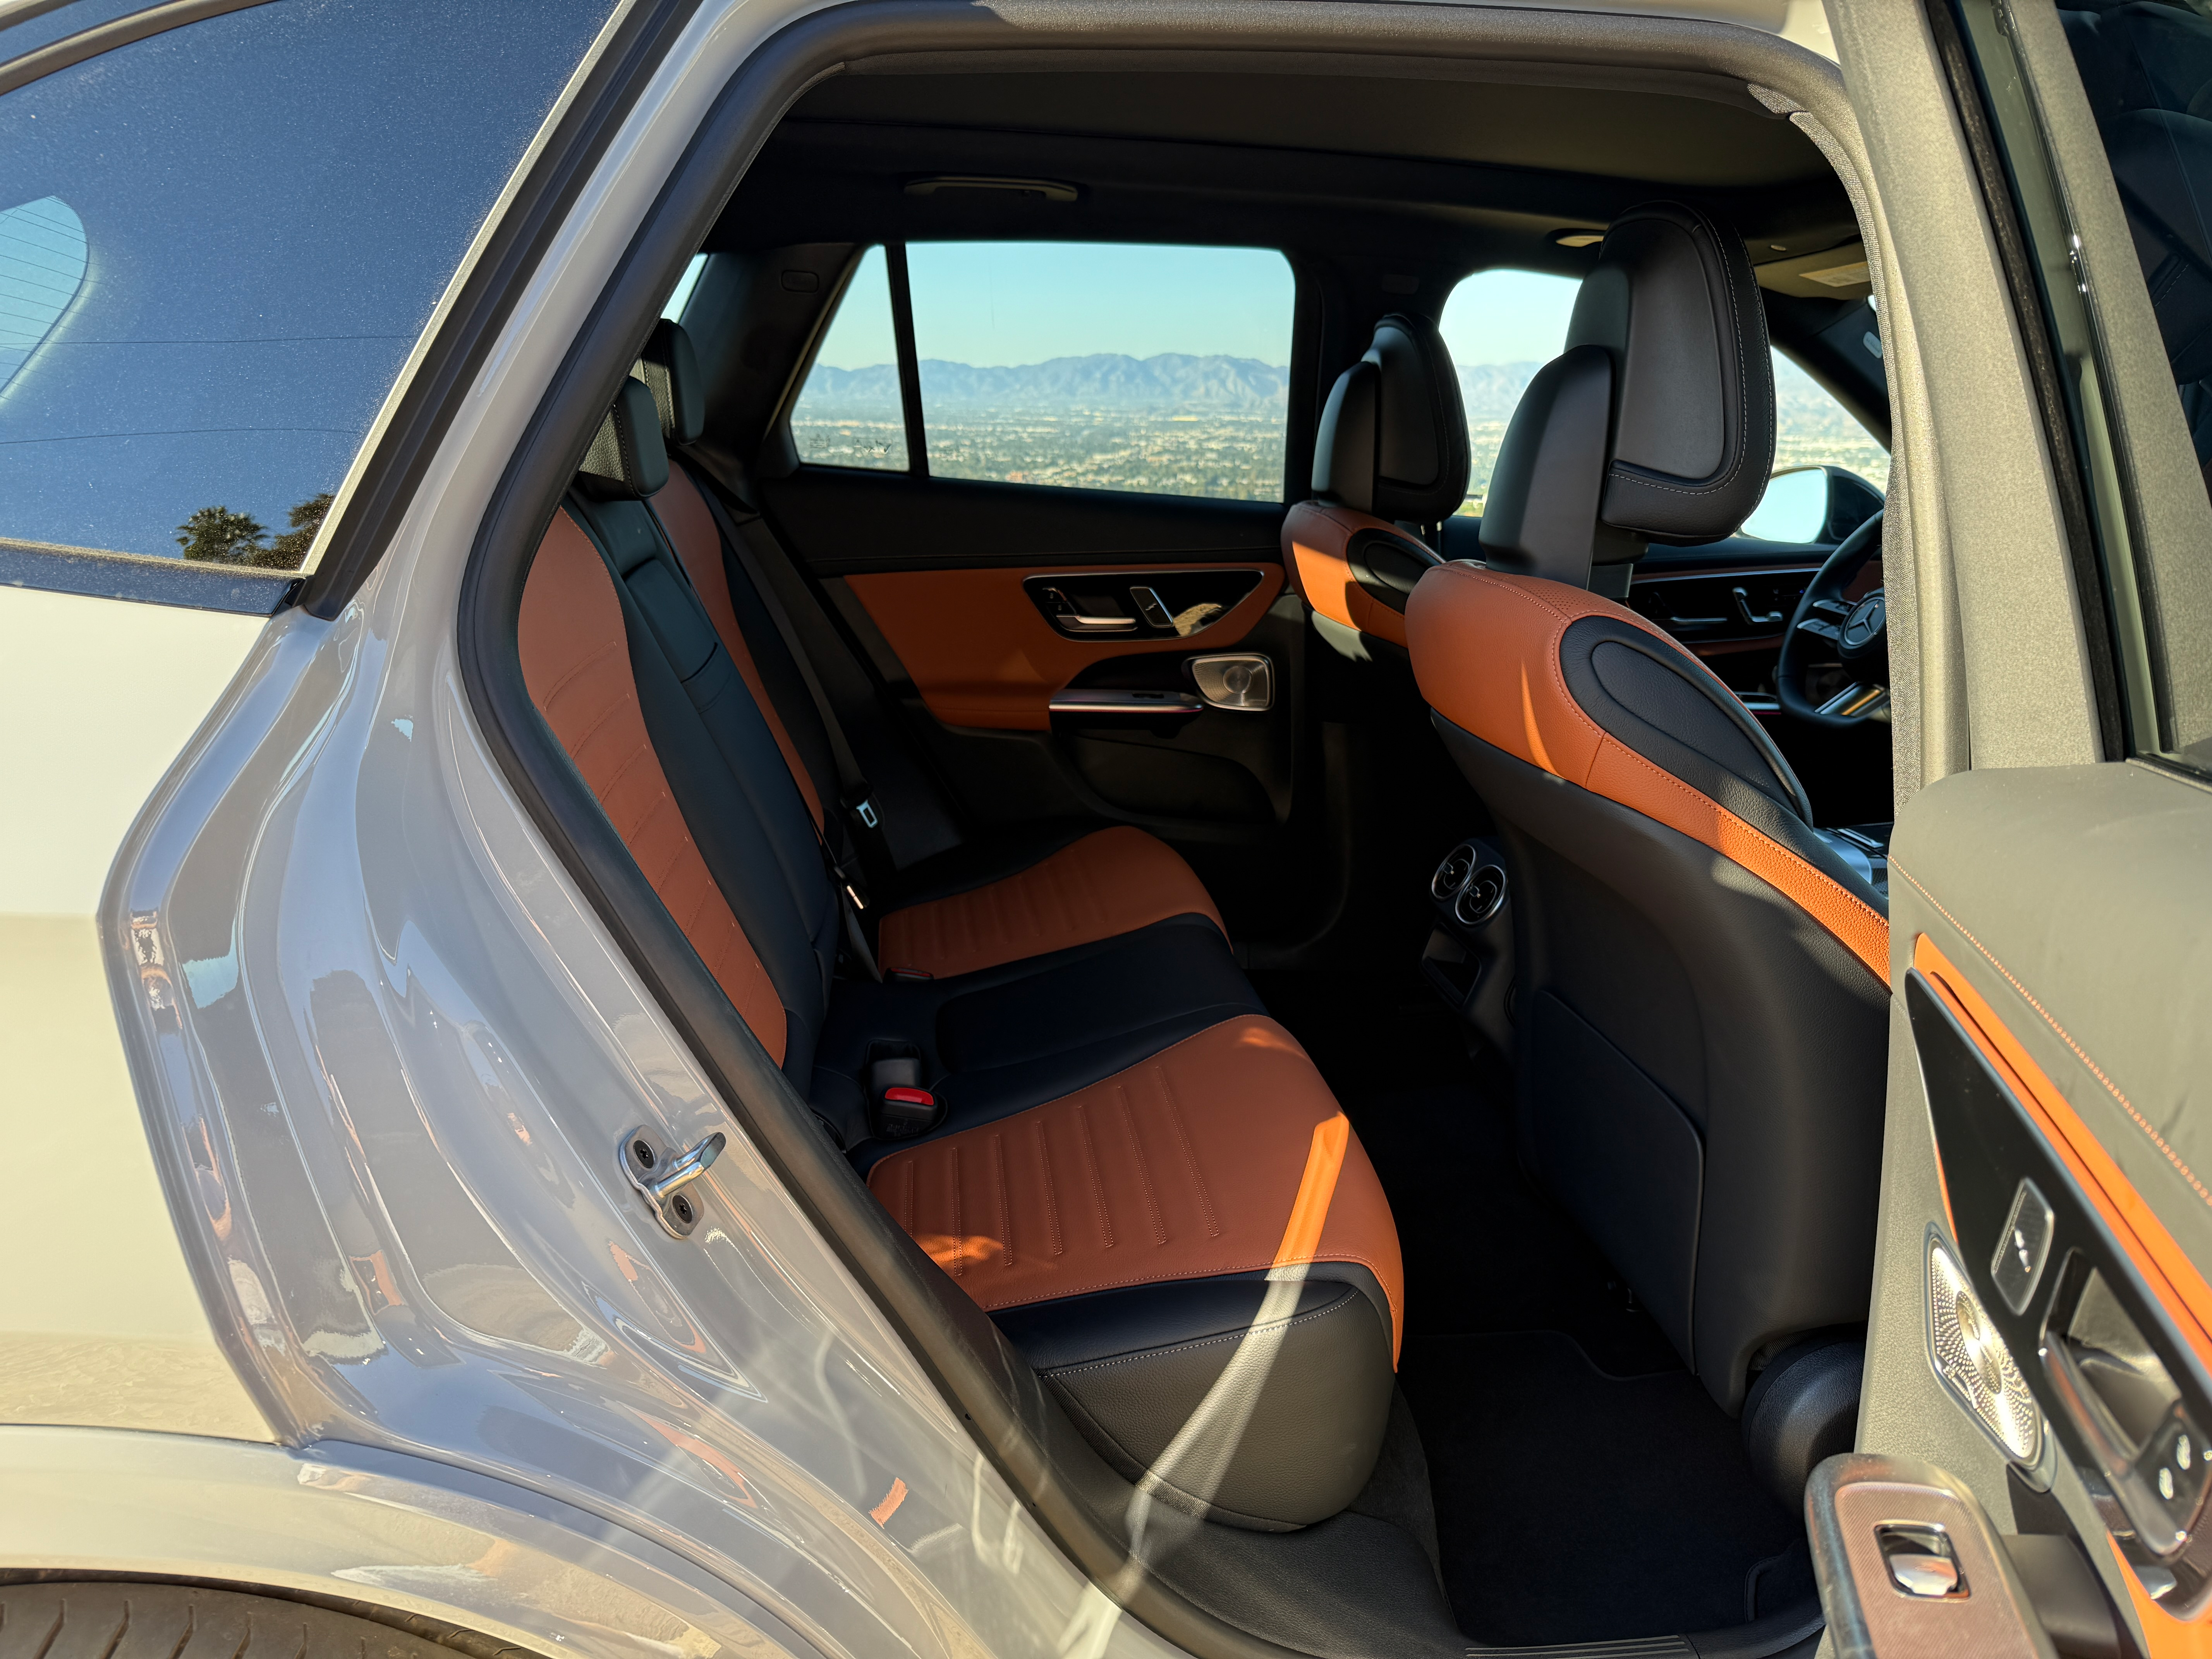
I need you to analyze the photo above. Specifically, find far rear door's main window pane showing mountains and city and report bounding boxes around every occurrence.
[907,241,1294,502]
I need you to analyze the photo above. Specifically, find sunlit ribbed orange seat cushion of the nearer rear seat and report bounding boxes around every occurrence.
[867,1015,1405,1354]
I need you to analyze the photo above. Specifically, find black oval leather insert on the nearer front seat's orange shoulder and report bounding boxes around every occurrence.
[1559,617,1889,916]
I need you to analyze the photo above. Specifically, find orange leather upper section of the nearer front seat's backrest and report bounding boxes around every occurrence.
[1405,564,1889,984]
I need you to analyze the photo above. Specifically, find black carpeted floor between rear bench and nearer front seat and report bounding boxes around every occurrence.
[1252,973,1812,1644]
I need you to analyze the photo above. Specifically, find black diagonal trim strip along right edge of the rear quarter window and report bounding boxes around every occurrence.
[301,0,699,619]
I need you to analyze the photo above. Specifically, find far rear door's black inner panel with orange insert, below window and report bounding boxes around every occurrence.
[759,467,1318,938]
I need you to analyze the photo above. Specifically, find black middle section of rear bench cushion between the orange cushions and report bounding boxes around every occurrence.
[812,916,1267,1175]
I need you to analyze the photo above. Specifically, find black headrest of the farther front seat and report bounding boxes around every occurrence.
[1314,312,1469,524]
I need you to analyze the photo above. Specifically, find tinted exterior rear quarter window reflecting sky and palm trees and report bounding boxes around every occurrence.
[0,0,611,568]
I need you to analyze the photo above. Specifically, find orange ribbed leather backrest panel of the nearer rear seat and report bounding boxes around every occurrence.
[518,511,785,1064]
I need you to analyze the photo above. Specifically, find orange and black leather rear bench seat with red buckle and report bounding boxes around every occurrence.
[518,354,1405,1528]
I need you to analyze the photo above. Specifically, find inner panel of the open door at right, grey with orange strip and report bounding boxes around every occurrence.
[1860,763,2212,1652]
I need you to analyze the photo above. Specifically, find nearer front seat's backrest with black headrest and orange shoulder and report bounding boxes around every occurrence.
[1405,204,1889,1411]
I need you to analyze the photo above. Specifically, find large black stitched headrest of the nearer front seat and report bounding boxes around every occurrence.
[1482,201,1774,586]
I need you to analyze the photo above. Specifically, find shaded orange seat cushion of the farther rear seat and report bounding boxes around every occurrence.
[876,825,1228,980]
